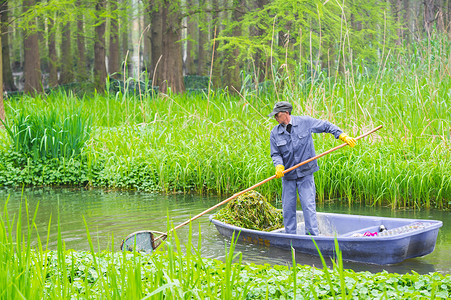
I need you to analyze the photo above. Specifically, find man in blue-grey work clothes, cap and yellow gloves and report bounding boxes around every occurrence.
[268,101,357,235]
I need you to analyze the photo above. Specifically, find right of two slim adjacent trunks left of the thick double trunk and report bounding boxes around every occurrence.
[108,1,121,78]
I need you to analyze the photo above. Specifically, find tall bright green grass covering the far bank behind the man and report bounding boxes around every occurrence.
[0,38,451,208]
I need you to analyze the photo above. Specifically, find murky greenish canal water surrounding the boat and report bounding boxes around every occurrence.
[0,188,451,274]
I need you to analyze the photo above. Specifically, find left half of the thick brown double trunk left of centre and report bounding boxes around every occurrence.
[150,0,163,86]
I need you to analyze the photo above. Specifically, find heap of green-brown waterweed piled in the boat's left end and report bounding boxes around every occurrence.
[215,191,283,231]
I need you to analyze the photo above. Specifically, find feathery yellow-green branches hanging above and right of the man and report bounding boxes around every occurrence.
[218,0,395,79]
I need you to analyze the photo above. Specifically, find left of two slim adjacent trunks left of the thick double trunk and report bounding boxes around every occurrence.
[94,0,106,91]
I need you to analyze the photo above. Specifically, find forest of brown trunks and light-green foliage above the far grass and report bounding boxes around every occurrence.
[0,0,451,93]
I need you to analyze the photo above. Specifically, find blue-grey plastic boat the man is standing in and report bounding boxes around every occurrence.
[210,211,443,265]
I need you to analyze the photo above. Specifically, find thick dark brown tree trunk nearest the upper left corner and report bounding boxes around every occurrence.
[23,0,42,93]
